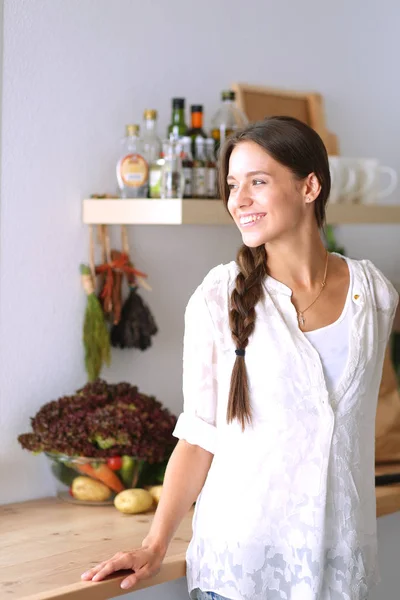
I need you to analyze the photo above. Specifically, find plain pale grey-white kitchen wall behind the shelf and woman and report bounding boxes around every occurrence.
[0,0,400,600]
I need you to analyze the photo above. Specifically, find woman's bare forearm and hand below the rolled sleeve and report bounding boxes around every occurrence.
[82,440,213,589]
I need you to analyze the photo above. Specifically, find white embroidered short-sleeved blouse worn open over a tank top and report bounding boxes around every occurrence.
[174,258,398,600]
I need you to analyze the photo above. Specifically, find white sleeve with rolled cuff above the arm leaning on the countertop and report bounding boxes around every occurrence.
[173,286,217,454]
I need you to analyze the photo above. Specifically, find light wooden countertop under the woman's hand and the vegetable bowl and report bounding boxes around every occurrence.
[0,482,400,600]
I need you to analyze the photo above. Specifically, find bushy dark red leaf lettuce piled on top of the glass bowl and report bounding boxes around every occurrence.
[18,379,176,464]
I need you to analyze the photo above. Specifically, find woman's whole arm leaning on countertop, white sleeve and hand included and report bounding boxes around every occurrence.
[82,272,217,589]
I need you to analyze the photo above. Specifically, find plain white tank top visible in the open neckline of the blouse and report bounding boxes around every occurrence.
[304,282,353,393]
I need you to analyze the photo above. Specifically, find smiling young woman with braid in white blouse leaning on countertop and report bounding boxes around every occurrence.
[82,117,398,600]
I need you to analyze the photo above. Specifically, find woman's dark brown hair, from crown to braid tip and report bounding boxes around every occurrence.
[218,117,331,430]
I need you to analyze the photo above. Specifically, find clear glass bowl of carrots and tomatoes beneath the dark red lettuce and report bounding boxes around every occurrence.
[45,452,146,506]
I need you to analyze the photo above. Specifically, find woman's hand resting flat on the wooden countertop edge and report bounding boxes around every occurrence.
[81,547,164,590]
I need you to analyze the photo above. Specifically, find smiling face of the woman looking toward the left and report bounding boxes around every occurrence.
[227,141,311,248]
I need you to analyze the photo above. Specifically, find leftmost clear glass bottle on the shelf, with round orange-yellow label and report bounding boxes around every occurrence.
[117,125,149,198]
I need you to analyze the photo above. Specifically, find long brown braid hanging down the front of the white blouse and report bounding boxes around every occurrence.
[227,245,267,430]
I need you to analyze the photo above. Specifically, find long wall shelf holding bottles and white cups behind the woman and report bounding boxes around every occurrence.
[83,198,400,225]
